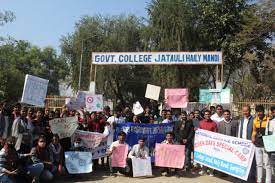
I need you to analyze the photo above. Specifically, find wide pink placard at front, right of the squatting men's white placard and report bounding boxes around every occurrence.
[155,144,185,168]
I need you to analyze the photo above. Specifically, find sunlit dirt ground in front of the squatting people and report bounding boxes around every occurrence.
[55,168,237,183]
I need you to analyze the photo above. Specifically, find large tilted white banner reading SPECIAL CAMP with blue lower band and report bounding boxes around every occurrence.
[194,129,255,180]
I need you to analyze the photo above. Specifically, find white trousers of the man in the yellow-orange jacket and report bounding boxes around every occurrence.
[256,147,272,183]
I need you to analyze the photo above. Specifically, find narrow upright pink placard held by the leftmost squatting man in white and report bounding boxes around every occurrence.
[111,144,128,168]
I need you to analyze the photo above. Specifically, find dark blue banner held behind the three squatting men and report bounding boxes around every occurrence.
[115,123,174,151]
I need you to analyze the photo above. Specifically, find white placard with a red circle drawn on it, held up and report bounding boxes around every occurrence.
[86,94,103,112]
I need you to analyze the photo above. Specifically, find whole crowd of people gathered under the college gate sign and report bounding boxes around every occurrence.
[0,102,275,183]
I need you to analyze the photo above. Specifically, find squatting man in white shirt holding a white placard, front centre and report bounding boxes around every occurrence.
[127,137,149,176]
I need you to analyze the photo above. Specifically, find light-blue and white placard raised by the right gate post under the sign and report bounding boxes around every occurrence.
[200,89,231,104]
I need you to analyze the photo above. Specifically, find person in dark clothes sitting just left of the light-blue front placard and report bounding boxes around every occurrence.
[49,134,63,175]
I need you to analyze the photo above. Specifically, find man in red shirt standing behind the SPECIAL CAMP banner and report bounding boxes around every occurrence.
[199,110,218,177]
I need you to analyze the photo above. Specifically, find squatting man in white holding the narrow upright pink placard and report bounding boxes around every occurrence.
[107,131,130,176]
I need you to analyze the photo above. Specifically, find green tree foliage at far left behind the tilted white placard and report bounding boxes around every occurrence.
[0,40,67,102]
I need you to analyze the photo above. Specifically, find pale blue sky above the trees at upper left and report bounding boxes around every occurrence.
[0,0,150,50]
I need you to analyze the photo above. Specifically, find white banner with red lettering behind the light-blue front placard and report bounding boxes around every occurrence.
[71,130,104,148]
